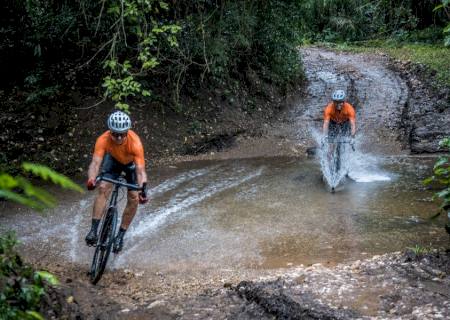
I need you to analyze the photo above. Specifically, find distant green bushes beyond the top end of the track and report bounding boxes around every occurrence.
[300,0,447,42]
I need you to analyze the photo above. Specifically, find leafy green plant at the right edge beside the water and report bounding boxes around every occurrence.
[424,138,450,211]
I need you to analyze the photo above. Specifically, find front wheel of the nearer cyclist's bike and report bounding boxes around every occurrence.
[90,208,117,284]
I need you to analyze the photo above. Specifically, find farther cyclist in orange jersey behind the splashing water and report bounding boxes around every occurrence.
[322,90,356,144]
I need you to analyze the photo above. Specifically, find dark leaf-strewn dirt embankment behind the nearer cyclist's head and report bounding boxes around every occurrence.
[0,71,296,176]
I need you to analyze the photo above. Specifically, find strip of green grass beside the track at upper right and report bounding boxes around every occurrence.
[326,40,450,87]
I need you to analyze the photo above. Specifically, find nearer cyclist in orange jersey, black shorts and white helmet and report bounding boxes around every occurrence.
[86,111,148,253]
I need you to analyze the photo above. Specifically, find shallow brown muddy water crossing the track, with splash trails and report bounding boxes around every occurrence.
[1,155,446,271]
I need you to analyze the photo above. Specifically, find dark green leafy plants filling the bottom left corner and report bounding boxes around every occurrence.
[0,233,58,320]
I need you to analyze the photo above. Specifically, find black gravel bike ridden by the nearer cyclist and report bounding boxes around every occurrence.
[89,176,142,284]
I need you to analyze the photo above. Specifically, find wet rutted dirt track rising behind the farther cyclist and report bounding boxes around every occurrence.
[182,48,412,159]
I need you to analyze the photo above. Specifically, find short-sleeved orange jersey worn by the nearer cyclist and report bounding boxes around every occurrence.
[94,130,145,166]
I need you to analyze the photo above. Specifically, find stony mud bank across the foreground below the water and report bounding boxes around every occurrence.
[37,251,450,319]
